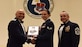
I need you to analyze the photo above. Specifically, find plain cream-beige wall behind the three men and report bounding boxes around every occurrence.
[0,0,82,47]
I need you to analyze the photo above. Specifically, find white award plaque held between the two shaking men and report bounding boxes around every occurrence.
[27,26,39,38]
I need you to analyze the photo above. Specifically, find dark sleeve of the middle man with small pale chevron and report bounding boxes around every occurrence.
[38,23,54,40]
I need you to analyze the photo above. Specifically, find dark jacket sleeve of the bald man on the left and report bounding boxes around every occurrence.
[8,21,26,41]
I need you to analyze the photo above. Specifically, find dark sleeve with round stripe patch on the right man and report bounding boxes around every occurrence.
[71,24,80,47]
